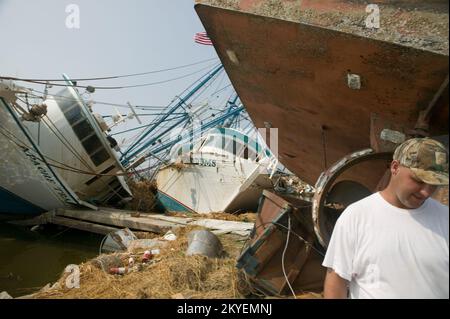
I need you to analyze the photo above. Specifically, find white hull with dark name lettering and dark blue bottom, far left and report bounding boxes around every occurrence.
[0,99,77,218]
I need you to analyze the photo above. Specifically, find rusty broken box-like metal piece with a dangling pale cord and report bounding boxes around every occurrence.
[237,191,325,296]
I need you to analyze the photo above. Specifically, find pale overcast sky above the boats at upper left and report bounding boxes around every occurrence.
[0,0,227,114]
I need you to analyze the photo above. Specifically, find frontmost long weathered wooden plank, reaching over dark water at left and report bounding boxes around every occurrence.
[56,210,180,234]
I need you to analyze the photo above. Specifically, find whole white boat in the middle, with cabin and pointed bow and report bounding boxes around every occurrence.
[156,128,277,214]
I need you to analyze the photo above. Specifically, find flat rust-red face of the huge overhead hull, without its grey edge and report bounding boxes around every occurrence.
[196,1,448,184]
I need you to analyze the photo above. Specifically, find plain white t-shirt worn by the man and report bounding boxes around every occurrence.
[323,193,449,298]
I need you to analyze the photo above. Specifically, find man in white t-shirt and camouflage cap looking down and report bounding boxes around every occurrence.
[323,138,449,299]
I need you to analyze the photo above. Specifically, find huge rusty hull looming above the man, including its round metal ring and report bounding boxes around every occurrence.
[195,0,449,247]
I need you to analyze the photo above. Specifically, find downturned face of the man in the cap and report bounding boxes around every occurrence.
[391,161,437,209]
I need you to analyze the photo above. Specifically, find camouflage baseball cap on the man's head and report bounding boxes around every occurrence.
[394,138,448,185]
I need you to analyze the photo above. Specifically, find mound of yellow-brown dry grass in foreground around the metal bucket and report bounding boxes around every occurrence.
[33,227,243,298]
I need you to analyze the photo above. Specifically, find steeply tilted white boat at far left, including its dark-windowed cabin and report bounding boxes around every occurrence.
[0,78,131,218]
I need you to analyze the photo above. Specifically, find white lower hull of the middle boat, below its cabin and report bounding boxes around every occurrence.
[157,164,272,214]
